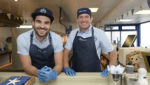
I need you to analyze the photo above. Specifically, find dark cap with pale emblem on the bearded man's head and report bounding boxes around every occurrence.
[32,8,54,22]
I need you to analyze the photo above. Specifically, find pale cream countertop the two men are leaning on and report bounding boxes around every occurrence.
[0,72,150,85]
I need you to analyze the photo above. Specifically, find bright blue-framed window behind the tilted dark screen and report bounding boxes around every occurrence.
[105,25,137,46]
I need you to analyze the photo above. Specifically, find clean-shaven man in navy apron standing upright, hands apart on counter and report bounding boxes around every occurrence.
[63,8,117,76]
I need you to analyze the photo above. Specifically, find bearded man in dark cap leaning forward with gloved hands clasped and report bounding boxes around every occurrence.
[17,8,63,82]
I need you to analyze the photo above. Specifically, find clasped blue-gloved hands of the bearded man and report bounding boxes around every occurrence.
[38,66,57,82]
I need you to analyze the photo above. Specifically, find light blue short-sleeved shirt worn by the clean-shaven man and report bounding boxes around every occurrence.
[65,25,114,58]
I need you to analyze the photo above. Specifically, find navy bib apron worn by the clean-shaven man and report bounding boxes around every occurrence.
[71,27,101,72]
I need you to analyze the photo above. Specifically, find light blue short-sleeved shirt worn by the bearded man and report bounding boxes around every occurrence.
[17,30,63,55]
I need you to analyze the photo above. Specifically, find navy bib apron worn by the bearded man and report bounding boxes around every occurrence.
[29,32,55,69]
